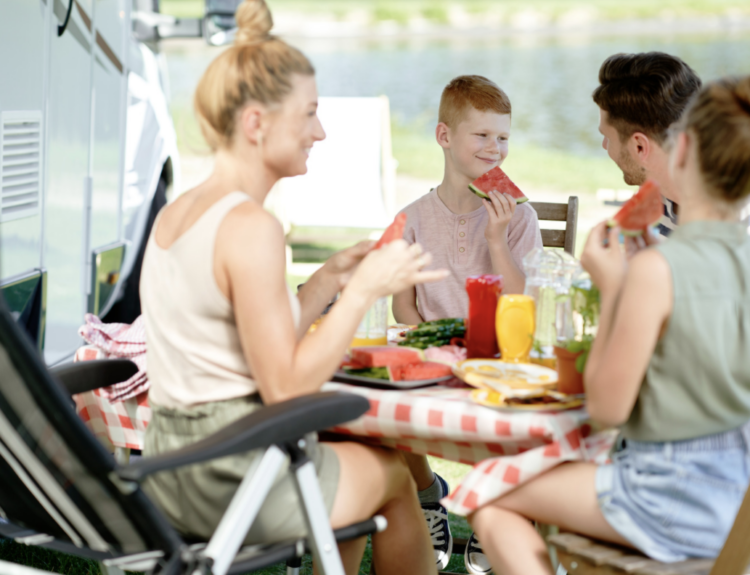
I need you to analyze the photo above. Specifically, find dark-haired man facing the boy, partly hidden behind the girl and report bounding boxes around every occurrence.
[593,52,701,236]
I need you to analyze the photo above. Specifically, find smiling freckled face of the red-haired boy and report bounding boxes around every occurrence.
[450,108,510,180]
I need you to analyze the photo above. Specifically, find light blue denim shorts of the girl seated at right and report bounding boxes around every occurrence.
[596,424,750,562]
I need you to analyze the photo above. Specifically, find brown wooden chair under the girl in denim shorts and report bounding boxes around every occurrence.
[547,484,750,575]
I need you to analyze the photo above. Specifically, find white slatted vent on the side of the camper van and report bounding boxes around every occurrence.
[0,112,42,223]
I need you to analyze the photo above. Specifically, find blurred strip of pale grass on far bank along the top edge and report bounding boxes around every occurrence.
[161,0,750,25]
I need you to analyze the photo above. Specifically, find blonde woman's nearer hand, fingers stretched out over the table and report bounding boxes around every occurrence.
[347,240,449,299]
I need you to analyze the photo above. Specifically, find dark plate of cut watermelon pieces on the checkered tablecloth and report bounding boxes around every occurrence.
[333,346,453,389]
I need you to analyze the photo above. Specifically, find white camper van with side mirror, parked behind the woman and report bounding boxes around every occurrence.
[0,0,237,364]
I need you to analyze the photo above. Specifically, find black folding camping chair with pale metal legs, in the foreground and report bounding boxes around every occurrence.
[0,297,385,575]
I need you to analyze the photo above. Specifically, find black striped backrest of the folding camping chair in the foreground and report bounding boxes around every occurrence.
[0,297,182,555]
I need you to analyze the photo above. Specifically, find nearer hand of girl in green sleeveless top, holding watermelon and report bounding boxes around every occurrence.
[581,221,627,293]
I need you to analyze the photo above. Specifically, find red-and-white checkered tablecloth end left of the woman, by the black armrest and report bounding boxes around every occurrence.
[73,345,151,449]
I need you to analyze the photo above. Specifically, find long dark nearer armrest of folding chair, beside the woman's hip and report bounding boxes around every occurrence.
[117,392,370,482]
